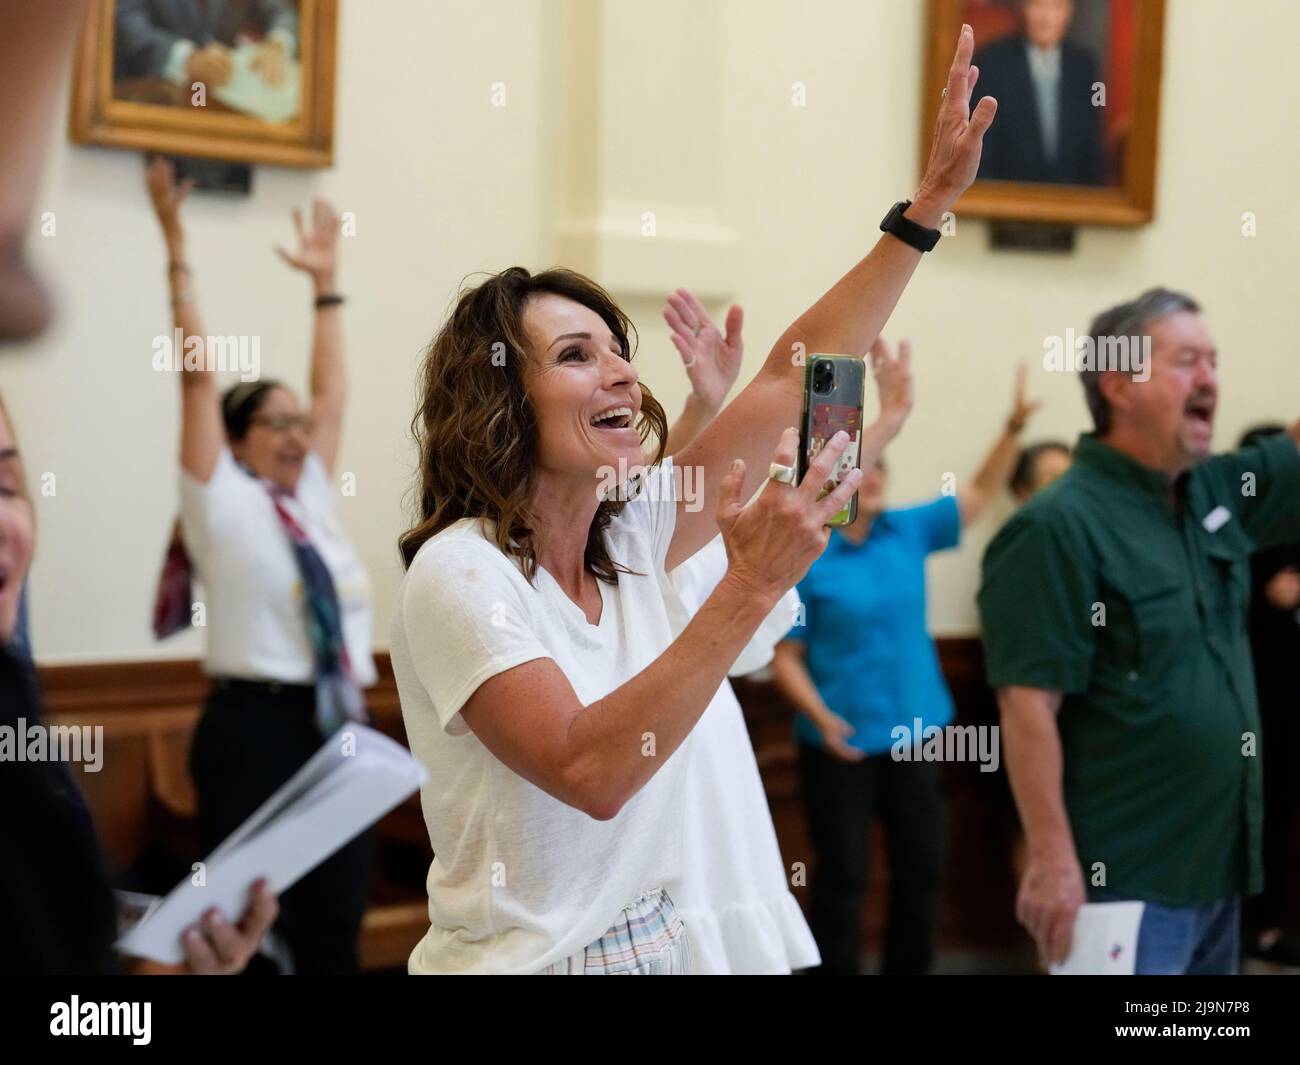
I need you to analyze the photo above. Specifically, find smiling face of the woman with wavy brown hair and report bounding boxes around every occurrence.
[524,293,642,484]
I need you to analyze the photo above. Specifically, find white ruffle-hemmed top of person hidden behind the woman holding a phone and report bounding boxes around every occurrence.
[668,536,822,975]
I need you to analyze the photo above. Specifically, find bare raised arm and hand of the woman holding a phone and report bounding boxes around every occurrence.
[667,26,997,570]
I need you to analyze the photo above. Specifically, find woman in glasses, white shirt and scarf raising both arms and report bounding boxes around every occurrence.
[148,159,376,973]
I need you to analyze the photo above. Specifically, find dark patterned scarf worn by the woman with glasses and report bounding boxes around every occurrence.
[153,470,367,736]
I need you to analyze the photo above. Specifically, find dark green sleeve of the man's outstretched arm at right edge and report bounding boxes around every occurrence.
[1201,433,1300,547]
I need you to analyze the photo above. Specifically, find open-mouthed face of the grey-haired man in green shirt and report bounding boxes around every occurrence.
[1106,311,1218,473]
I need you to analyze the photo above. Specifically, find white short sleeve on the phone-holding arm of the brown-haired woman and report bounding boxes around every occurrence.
[400,541,553,736]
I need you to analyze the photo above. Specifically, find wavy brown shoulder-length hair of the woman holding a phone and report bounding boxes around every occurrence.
[398,267,668,584]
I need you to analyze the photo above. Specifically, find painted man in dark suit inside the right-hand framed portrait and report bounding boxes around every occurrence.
[971,0,1110,185]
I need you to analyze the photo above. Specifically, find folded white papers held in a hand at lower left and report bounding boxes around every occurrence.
[117,724,428,965]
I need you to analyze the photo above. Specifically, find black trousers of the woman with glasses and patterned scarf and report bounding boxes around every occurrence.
[190,681,372,974]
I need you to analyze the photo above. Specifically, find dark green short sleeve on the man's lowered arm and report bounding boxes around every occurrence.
[979,505,1099,693]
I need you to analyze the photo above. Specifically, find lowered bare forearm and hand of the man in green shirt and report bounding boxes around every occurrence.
[997,687,1087,962]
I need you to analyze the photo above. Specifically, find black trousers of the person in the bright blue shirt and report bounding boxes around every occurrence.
[800,744,944,975]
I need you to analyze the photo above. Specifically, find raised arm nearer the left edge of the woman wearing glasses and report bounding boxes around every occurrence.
[146,156,225,484]
